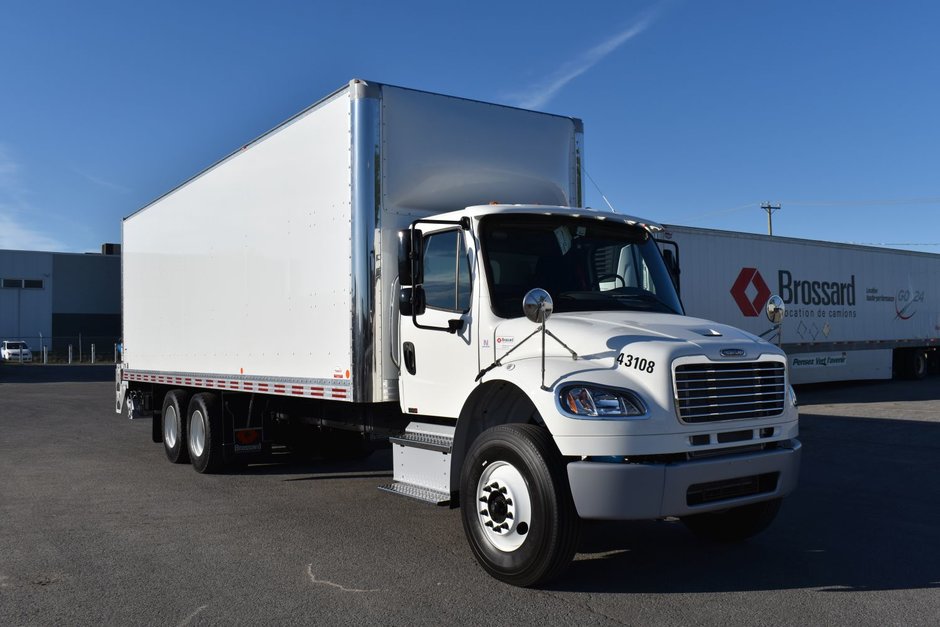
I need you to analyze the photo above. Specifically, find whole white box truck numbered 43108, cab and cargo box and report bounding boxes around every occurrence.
[116,80,800,586]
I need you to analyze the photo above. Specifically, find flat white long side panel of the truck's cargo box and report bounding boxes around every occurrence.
[123,92,351,379]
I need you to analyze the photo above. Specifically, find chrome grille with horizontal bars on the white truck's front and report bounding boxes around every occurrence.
[675,361,786,423]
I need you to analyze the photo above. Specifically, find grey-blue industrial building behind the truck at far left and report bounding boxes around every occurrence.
[0,244,121,360]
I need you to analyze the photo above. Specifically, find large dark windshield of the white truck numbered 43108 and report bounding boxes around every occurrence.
[480,214,682,318]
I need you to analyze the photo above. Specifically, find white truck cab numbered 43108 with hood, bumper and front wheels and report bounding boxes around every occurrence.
[391,205,800,585]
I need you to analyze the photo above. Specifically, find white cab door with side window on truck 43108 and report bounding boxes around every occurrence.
[399,228,479,418]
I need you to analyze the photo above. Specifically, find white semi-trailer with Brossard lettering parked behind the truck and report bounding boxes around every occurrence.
[657,225,940,384]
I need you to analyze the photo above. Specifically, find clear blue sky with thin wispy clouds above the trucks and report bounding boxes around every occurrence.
[0,0,940,253]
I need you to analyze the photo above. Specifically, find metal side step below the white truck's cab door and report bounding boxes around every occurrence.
[379,422,455,505]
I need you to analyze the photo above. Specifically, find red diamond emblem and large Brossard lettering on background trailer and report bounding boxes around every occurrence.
[731,268,855,318]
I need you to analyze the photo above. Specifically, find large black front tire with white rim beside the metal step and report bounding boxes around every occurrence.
[460,424,580,587]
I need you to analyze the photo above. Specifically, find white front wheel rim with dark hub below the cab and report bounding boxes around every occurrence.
[476,461,532,553]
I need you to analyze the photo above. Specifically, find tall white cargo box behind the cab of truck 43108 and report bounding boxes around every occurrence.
[123,81,581,402]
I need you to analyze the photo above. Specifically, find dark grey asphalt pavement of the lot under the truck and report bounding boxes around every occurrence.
[0,365,940,625]
